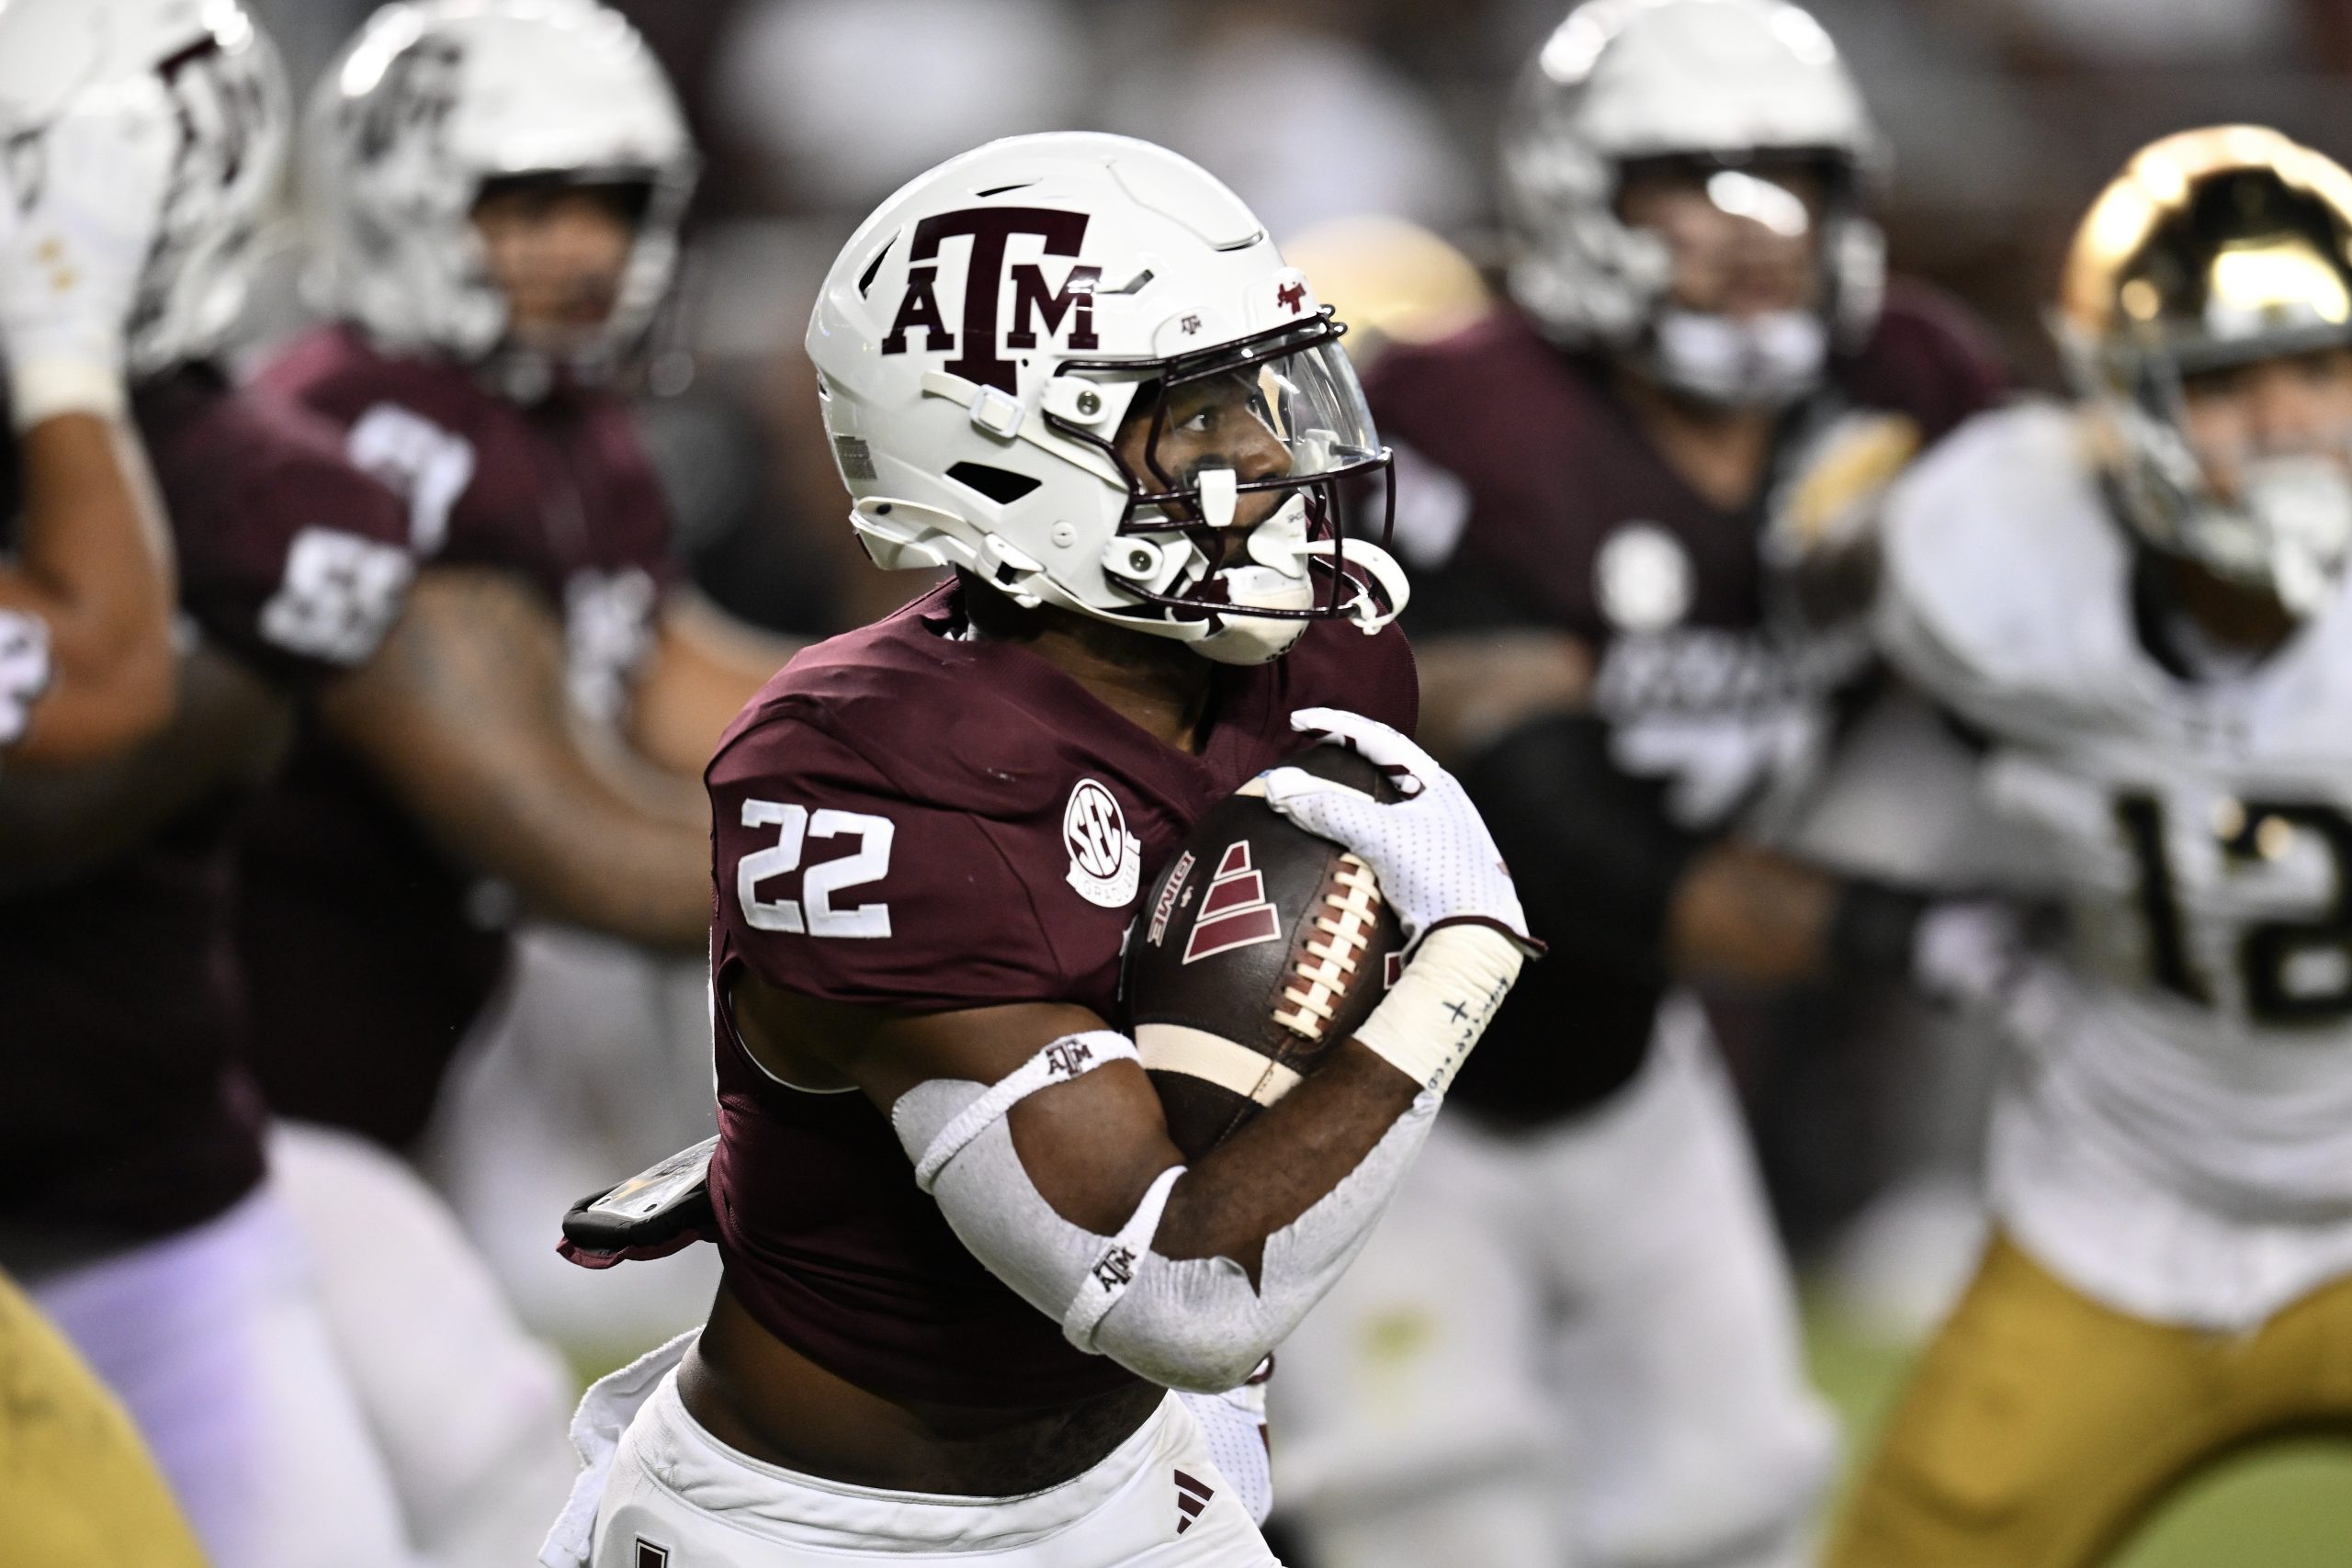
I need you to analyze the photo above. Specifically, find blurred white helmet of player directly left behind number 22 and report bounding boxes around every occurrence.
[303,0,698,378]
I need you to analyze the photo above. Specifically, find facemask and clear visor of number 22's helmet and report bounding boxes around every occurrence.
[1046,308,1404,665]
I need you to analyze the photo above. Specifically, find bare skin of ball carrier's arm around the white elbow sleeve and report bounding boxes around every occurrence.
[731,976,1419,1279]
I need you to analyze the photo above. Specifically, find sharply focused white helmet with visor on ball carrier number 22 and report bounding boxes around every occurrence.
[809,131,1407,663]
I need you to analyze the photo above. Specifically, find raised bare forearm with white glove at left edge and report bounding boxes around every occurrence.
[0,76,174,764]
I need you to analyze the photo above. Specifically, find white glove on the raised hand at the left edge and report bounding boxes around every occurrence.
[0,80,179,430]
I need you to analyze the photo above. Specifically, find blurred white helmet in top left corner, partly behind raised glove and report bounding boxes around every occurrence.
[0,0,289,378]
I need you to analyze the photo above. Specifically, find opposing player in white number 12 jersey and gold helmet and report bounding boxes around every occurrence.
[1832,125,2352,1568]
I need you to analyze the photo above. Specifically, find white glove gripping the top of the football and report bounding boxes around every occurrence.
[1263,707,1538,952]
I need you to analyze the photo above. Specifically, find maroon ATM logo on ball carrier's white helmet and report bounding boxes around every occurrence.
[882,207,1103,392]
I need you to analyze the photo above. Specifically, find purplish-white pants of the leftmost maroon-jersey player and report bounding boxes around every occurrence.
[30,1185,419,1568]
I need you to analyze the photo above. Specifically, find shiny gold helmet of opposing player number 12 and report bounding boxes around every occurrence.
[2053,125,2352,614]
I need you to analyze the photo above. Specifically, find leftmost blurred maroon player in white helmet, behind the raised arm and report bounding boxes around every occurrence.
[0,0,442,1568]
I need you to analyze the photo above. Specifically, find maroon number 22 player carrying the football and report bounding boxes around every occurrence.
[543,134,1521,1568]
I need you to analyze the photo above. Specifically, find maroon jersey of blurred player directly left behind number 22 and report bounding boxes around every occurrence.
[238,327,671,1145]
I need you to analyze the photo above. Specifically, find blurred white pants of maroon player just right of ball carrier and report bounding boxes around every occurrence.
[1270,999,1835,1568]
